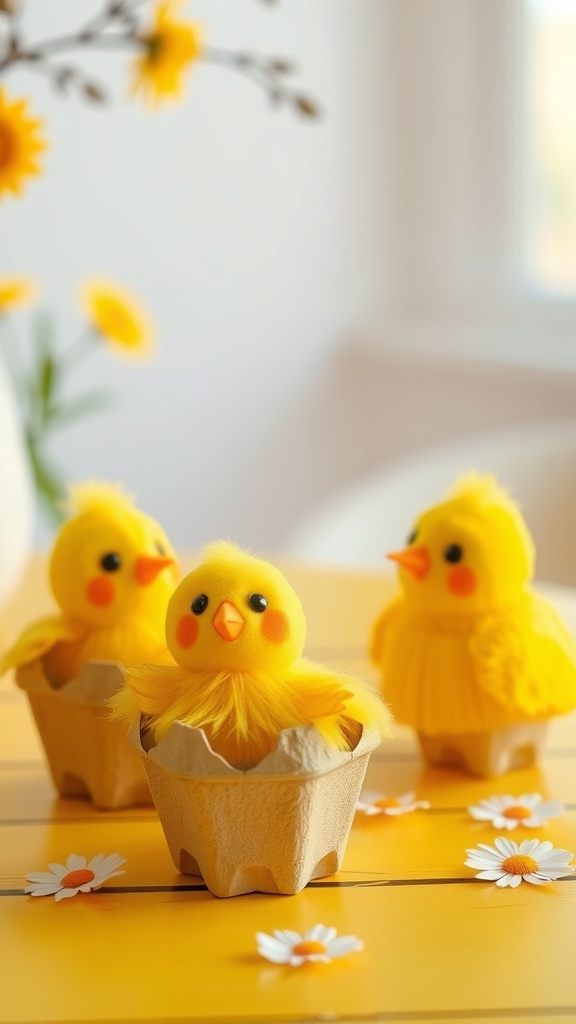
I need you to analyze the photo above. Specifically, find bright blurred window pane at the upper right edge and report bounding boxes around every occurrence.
[522,0,576,299]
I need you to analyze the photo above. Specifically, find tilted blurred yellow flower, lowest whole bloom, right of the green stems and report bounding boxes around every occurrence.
[80,278,155,355]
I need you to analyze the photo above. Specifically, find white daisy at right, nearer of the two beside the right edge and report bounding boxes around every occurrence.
[464,836,576,889]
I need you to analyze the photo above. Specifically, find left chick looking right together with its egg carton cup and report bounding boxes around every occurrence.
[0,483,177,808]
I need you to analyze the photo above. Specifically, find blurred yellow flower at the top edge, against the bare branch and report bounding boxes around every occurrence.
[131,0,203,103]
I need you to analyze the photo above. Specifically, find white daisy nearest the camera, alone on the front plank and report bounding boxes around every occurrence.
[256,925,364,967]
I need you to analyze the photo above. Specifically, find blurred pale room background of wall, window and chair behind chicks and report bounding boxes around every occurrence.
[0,0,576,583]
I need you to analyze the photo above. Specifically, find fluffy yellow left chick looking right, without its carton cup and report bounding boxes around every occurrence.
[0,483,177,687]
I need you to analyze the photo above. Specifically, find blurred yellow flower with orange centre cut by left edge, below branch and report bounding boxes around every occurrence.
[0,88,46,199]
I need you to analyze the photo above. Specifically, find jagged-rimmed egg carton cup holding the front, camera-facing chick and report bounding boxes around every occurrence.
[130,720,380,897]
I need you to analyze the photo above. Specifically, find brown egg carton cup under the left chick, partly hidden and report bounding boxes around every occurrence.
[16,660,153,810]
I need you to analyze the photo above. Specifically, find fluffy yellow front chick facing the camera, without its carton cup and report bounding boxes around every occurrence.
[112,542,389,770]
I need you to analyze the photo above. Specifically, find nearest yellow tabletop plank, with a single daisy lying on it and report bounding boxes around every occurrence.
[0,883,576,1024]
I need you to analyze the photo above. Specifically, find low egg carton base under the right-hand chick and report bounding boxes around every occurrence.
[418,720,548,778]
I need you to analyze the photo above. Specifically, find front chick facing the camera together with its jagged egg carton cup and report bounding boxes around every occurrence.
[112,542,389,896]
